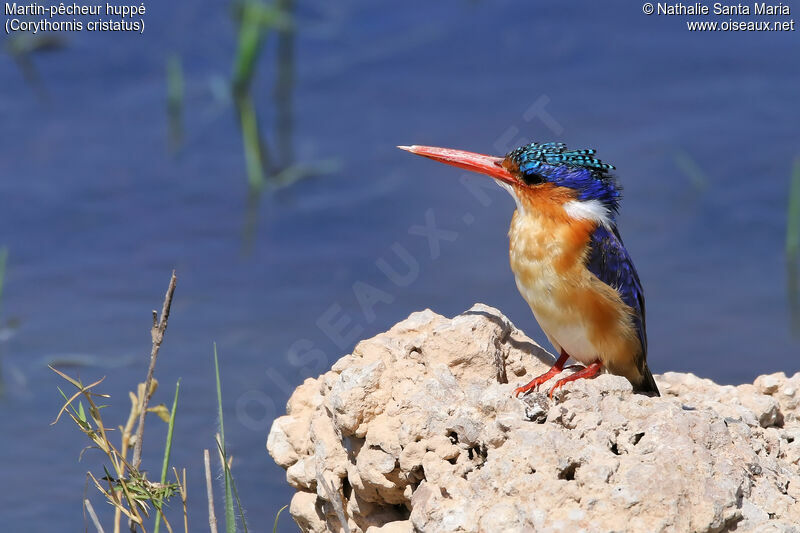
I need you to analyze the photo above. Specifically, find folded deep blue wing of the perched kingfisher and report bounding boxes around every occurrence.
[586,225,647,360]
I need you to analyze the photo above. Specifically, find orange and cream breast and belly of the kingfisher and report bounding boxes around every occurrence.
[509,186,641,379]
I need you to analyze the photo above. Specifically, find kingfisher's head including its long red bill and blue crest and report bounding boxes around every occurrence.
[398,142,621,220]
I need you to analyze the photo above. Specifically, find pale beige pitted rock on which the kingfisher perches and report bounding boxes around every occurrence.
[267,304,800,533]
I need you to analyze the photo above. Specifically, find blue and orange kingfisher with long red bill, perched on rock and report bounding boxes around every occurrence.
[398,142,660,398]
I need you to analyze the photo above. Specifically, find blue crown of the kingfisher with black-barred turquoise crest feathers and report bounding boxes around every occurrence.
[504,142,621,211]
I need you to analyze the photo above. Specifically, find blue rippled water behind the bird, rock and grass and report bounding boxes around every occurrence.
[0,1,800,531]
